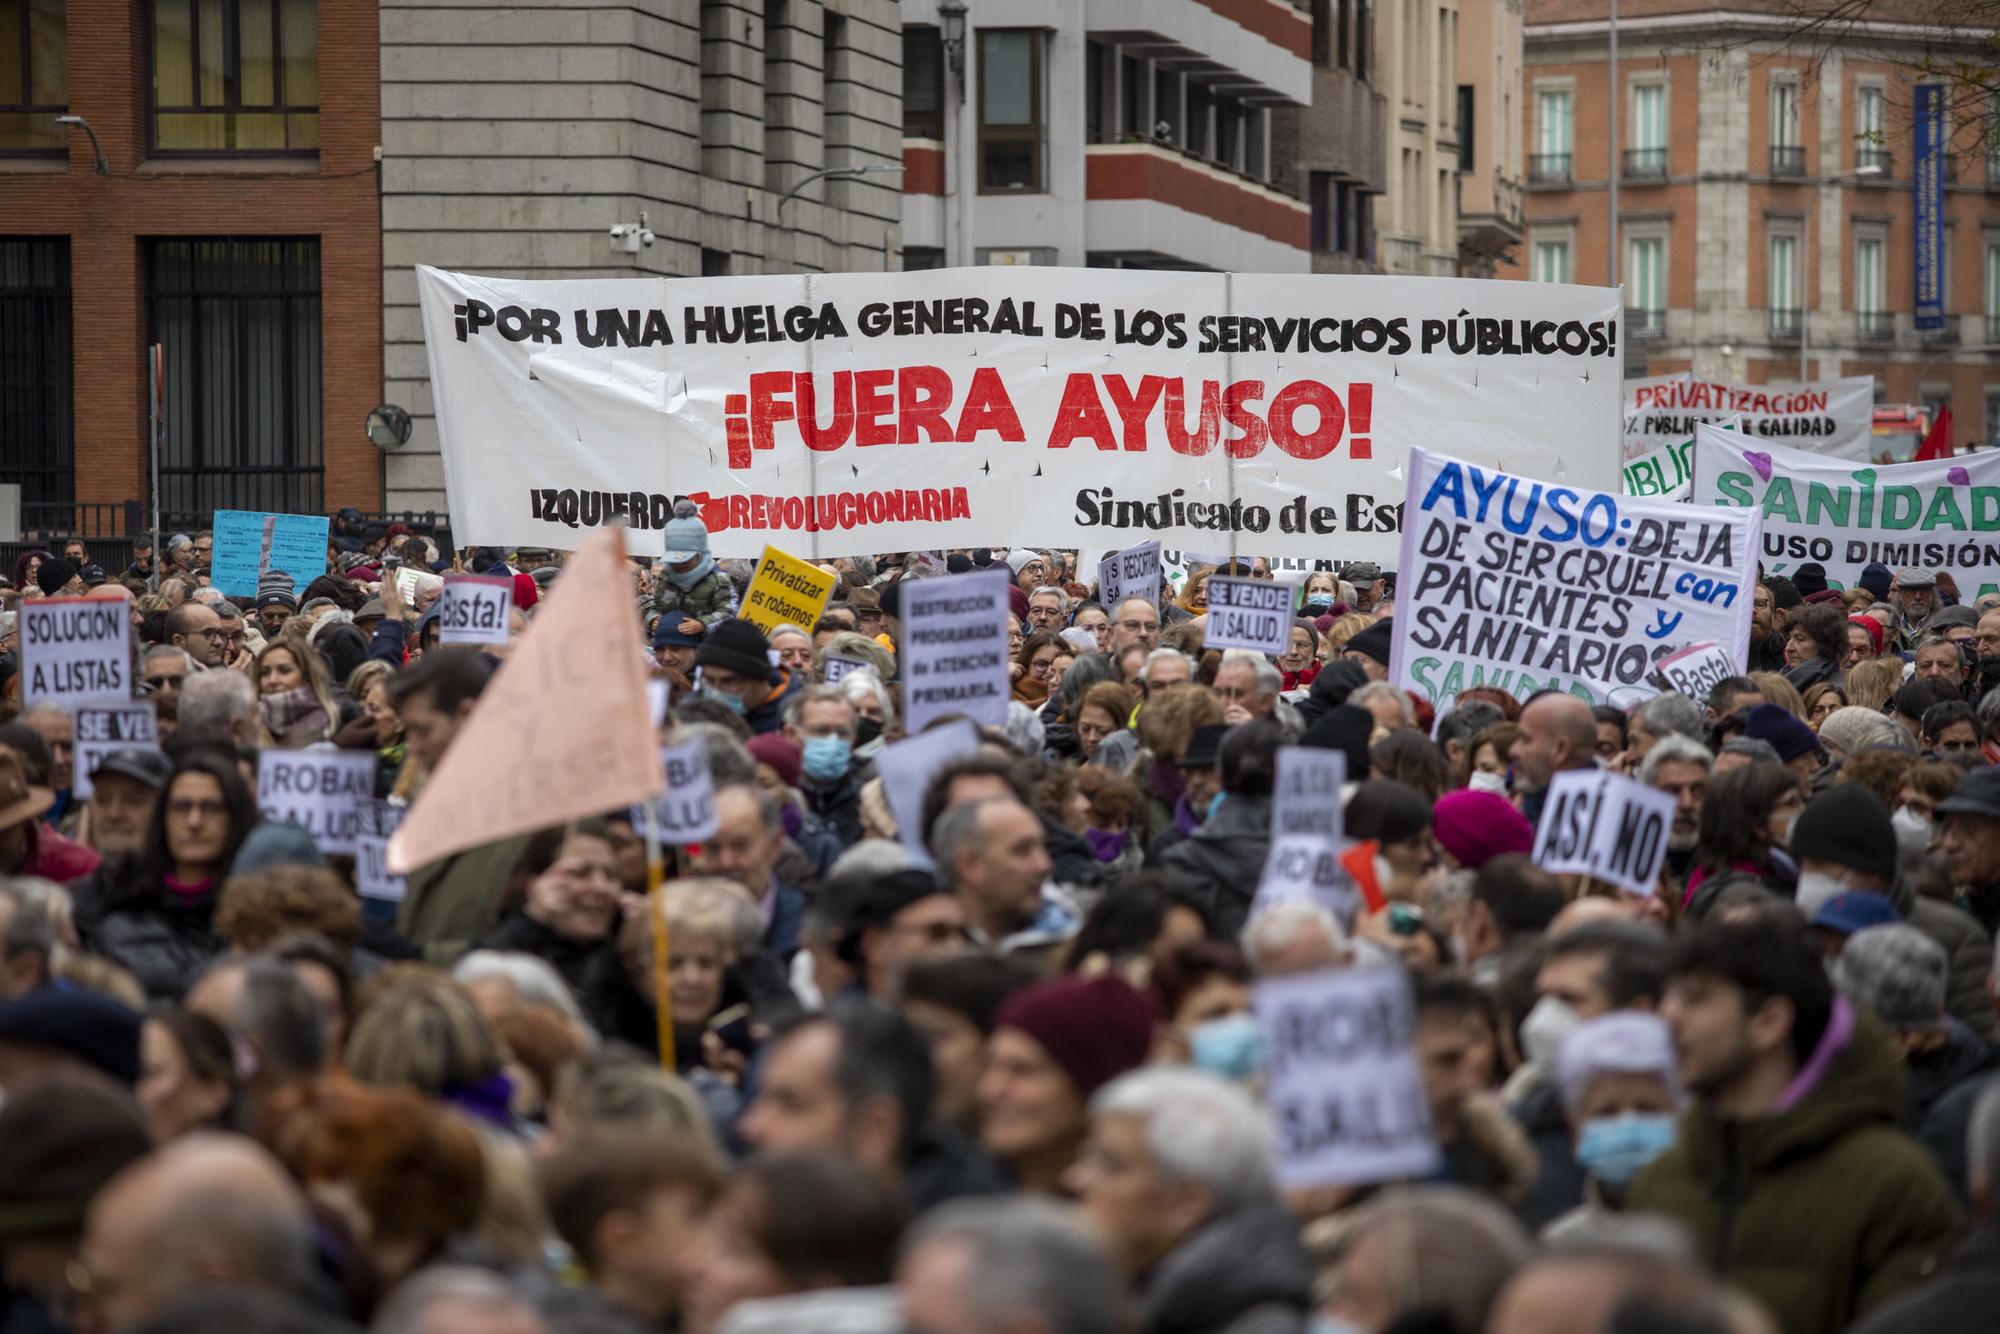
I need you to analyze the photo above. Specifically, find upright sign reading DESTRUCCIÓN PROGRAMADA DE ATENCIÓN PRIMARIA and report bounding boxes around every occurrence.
[902,566,1012,732]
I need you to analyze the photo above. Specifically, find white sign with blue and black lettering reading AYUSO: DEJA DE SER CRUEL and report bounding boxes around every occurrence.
[1390,450,1758,706]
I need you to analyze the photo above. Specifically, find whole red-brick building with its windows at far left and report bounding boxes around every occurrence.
[0,0,382,536]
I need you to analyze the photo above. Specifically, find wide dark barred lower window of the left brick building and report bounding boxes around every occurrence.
[146,238,326,514]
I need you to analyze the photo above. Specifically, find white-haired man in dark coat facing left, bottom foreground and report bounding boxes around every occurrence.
[1068,1066,1312,1330]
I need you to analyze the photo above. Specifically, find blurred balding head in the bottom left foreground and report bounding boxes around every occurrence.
[70,1134,314,1334]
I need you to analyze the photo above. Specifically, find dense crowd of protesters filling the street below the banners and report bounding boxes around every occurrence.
[0,512,2000,1334]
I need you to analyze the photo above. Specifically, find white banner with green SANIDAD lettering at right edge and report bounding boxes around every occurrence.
[1694,428,2000,602]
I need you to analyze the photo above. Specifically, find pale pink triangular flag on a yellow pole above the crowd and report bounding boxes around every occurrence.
[388,528,666,874]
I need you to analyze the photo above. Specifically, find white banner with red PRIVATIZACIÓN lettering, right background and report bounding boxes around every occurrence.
[1624,372,1874,462]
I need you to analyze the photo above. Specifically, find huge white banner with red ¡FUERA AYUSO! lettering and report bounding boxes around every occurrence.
[418,268,1624,560]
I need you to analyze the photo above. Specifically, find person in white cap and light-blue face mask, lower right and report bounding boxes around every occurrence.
[1542,1010,1680,1244]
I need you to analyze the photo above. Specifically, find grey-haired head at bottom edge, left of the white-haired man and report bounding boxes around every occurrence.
[896,1196,1124,1334]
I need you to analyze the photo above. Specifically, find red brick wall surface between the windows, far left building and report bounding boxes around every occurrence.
[0,0,382,510]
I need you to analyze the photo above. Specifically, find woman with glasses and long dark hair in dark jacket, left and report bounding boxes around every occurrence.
[70,746,258,1002]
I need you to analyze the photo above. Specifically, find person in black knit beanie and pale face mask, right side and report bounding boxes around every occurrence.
[1792,782,2000,1042]
